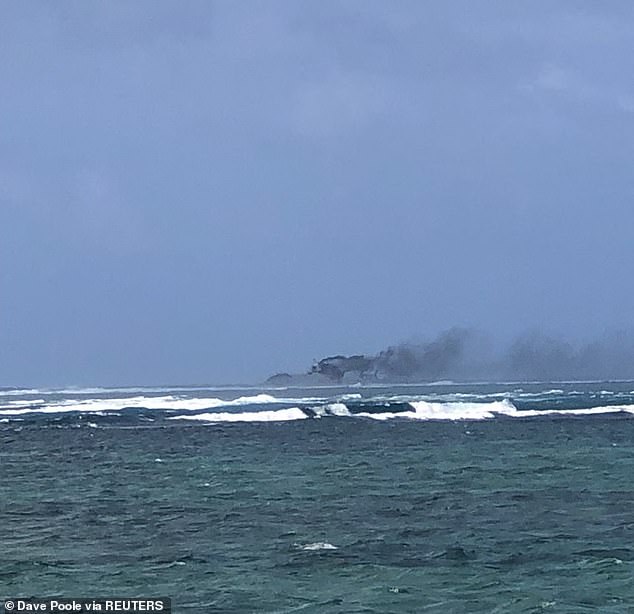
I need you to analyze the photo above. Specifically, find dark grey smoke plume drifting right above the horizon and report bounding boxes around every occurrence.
[278,328,634,382]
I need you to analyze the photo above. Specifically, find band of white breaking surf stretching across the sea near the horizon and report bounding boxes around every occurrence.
[0,382,634,425]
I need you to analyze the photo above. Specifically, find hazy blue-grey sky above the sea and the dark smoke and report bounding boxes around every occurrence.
[0,0,634,386]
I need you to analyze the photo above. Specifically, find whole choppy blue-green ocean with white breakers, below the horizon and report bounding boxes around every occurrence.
[0,382,634,614]
